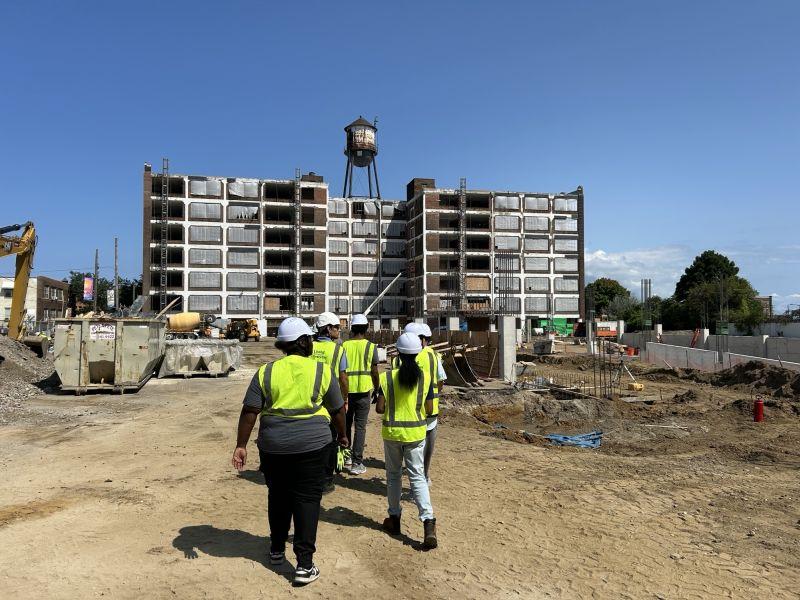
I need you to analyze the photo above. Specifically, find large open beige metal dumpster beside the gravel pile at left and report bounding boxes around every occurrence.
[53,317,165,394]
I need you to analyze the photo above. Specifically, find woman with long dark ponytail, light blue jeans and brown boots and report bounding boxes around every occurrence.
[375,333,437,548]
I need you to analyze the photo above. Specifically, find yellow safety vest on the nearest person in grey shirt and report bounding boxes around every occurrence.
[258,354,331,422]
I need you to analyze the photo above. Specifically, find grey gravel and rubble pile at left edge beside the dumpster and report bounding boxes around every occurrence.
[0,336,58,424]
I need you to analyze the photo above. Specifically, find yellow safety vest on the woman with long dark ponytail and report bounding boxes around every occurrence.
[380,369,431,443]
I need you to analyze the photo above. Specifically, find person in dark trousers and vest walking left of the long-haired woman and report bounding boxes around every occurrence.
[342,314,380,475]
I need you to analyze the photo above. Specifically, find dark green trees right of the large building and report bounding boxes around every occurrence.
[586,250,764,333]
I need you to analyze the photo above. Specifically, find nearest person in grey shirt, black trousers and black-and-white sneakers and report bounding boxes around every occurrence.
[232,317,348,585]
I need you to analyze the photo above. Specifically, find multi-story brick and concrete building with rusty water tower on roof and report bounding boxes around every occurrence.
[143,120,584,329]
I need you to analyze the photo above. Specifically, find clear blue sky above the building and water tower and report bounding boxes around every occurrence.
[0,0,800,306]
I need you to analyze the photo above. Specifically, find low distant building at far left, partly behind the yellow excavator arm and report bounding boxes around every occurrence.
[0,276,69,331]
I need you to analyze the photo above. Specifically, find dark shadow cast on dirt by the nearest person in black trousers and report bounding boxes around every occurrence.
[172,525,294,581]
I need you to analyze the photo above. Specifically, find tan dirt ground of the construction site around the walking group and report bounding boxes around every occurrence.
[0,342,800,599]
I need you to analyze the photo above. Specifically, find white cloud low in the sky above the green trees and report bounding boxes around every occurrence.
[585,246,694,297]
